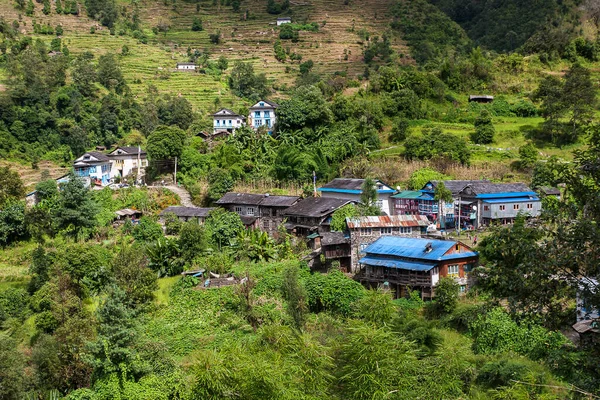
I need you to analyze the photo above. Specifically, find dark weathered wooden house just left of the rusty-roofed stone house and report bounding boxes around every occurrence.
[283,197,353,236]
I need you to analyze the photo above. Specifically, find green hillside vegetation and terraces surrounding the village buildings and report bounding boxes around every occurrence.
[0,0,600,400]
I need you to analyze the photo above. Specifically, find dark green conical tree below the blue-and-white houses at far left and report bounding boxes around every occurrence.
[53,174,98,236]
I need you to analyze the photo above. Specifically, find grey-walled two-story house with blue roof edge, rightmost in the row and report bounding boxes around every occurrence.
[458,182,542,227]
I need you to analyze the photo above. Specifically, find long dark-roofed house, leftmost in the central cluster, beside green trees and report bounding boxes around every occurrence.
[217,192,300,235]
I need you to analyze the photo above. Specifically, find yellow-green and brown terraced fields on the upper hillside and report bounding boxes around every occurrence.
[0,0,411,112]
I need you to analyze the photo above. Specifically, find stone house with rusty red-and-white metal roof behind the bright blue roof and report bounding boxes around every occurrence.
[346,215,430,273]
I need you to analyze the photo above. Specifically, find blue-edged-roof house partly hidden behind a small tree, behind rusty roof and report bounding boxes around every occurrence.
[317,178,396,215]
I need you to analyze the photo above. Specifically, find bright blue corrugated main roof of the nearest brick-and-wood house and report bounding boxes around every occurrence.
[364,236,477,261]
